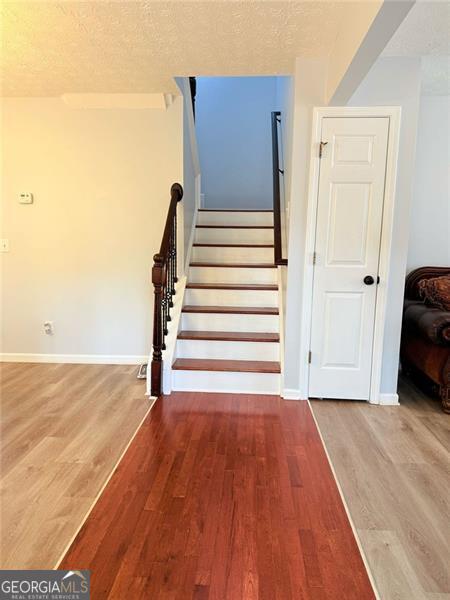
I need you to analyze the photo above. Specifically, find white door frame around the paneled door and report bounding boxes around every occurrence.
[300,106,401,404]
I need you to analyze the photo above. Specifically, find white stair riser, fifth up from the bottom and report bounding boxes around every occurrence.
[189,267,277,284]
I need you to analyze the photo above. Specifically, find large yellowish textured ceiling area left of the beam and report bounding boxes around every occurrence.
[0,0,342,96]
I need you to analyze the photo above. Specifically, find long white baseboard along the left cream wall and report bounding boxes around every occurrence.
[0,352,148,365]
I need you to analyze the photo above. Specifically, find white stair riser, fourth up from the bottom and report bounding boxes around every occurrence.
[185,288,278,310]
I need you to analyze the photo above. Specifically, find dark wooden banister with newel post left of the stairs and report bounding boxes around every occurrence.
[151,183,183,396]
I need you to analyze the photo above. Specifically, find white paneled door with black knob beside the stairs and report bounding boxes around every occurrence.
[309,117,389,400]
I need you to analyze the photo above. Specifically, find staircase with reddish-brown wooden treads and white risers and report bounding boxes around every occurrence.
[172,209,280,394]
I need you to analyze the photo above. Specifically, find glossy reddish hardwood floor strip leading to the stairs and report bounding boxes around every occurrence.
[60,393,374,600]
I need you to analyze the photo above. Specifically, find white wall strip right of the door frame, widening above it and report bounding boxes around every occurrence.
[349,58,421,394]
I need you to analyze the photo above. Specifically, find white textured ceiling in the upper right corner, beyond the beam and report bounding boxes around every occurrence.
[383,0,450,95]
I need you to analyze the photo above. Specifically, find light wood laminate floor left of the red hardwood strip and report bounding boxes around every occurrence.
[0,363,150,569]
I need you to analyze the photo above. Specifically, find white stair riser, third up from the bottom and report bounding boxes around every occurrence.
[181,313,279,333]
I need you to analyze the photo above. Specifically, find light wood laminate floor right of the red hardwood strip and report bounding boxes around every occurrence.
[311,381,450,600]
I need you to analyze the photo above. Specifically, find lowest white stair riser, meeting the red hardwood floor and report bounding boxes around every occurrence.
[172,371,280,395]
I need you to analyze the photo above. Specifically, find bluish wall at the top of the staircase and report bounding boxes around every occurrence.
[196,77,277,208]
